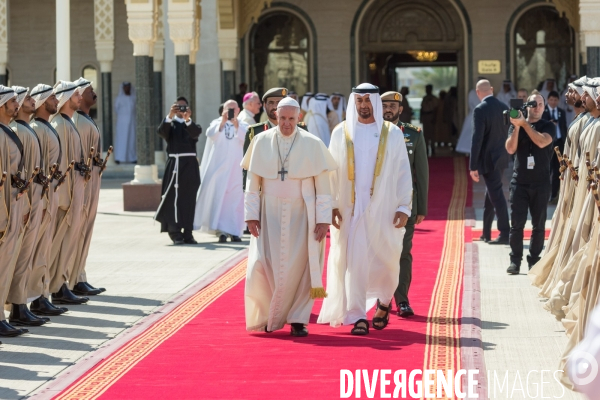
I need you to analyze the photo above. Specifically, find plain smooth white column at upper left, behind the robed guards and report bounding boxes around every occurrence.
[56,0,72,81]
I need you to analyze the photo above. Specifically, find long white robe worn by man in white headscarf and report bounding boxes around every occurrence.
[318,120,413,326]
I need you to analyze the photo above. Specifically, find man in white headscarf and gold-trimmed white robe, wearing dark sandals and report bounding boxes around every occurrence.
[318,83,412,335]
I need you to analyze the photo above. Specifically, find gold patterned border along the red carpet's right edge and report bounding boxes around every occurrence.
[423,157,468,398]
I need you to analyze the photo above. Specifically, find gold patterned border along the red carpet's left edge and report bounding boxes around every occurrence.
[55,259,247,400]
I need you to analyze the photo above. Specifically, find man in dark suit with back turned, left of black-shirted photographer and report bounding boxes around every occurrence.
[469,79,510,244]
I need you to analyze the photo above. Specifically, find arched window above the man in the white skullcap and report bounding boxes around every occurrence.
[250,10,312,93]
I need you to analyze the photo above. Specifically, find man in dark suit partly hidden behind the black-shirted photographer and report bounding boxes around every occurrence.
[542,90,569,204]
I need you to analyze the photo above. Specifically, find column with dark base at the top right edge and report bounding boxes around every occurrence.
[579,0,600,77]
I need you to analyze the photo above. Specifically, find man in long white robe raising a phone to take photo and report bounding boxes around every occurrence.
[194,100,248,243]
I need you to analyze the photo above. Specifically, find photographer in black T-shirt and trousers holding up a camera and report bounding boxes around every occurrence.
[506,92,556,275]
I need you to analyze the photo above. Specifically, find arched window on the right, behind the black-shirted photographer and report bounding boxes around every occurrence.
[512,6,576,90]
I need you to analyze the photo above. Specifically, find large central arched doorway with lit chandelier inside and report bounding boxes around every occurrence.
[354,0,467,127]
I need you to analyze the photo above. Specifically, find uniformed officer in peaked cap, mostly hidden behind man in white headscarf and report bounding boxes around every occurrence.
[381,92,429,318]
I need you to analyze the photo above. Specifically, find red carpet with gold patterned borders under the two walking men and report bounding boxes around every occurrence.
[57,158,467,399]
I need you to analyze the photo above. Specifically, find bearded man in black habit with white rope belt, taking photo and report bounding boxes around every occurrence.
[154,97,202,245]
